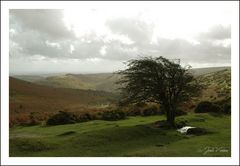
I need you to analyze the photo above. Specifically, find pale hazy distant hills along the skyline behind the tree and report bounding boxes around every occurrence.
[14,67,230,92]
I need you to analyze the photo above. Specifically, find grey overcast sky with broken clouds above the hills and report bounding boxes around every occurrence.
[9,2,232,74]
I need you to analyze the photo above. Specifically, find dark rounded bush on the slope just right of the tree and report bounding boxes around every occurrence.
[194,101,221,113]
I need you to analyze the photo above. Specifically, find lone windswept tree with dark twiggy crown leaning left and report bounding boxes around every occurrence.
[117,57,200,126]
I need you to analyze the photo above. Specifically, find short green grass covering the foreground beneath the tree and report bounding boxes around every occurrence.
[10,113,231,157]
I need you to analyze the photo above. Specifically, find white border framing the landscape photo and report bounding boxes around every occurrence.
[1,1,239,165]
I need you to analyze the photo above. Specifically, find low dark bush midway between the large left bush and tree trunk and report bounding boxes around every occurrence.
[102,110,126,121]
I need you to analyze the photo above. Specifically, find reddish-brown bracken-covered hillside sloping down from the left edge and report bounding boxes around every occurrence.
[9,77,116,126]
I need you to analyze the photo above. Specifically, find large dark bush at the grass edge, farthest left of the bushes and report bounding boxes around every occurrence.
[46,111,77,125]
